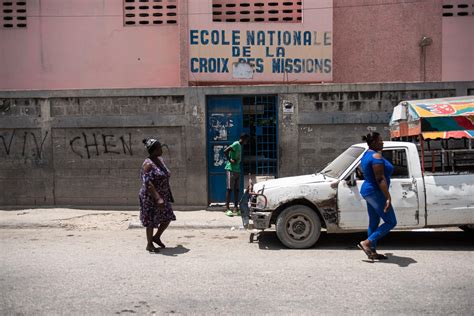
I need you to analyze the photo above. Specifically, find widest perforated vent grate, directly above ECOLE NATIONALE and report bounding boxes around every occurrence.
[212,0,303,23]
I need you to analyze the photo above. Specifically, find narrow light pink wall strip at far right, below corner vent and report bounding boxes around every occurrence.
[442,16,474,81]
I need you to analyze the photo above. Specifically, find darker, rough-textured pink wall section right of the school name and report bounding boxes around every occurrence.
[333,0,442,83]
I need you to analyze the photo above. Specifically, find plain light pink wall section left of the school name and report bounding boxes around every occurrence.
[0,0,180,90]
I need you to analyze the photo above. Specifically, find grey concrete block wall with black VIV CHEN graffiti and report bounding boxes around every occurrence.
[0,82,474,208]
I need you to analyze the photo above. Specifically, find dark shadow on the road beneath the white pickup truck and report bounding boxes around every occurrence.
[257,231,474,252]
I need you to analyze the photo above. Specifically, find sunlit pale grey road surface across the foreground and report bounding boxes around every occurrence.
[0,228,474,315]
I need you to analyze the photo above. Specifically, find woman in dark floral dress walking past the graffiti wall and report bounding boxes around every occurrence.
[139,138,176,252]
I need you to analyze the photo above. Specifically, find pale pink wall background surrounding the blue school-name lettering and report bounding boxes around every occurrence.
[188,0,333,84]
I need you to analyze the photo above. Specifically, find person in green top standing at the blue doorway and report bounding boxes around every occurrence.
[224,133,250,216]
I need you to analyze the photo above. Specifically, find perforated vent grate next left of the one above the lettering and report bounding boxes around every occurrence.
[123,0,178,26]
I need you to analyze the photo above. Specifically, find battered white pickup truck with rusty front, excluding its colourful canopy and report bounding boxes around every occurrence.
[250,141,474,248]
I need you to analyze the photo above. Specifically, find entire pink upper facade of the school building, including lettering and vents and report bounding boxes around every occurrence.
[0,0,474,90]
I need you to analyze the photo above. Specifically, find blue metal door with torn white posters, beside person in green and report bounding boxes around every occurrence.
[207,96,243,203]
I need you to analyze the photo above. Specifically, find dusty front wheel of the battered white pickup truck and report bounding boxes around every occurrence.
[276,205,321,249]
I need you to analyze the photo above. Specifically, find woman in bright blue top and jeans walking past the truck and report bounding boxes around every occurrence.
[357,132,397,259]
